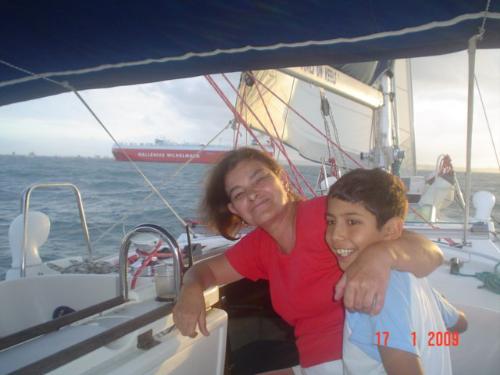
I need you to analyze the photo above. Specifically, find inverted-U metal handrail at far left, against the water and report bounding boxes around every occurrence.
[20,182,92,278]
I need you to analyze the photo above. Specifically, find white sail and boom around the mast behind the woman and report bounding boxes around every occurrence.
[237,60,414,171]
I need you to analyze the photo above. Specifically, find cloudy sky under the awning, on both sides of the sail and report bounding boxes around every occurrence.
[0,50,500,171]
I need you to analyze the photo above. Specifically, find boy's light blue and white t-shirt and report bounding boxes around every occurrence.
[343,271,458,374]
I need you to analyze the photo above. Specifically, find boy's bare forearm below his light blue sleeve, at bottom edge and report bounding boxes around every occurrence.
[378,346,424,375]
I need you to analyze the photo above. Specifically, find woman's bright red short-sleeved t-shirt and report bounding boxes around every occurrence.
[226,197,344,367]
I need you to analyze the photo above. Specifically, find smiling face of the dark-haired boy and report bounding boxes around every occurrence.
[326,198,385,271]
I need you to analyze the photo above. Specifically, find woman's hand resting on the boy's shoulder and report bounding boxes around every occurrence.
[335,243,394,315]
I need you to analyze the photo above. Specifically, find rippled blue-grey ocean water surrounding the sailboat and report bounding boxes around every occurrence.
[0,155,500,279]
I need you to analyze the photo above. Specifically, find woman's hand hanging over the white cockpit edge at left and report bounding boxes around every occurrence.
[173,285,209,337]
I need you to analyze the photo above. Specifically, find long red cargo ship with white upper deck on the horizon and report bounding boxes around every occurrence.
[112,139,273,164]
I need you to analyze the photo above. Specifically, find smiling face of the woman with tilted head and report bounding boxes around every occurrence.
[224,160,288,226]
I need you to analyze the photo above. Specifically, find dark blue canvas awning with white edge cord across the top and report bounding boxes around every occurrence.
[0,0,500,105]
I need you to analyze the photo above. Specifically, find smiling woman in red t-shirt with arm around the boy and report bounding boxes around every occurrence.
[174,148,442,374]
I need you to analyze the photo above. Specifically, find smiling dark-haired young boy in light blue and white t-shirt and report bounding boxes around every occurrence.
[326,169,467,374]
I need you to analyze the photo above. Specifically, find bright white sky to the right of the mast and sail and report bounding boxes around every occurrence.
[412,50,500,168]
